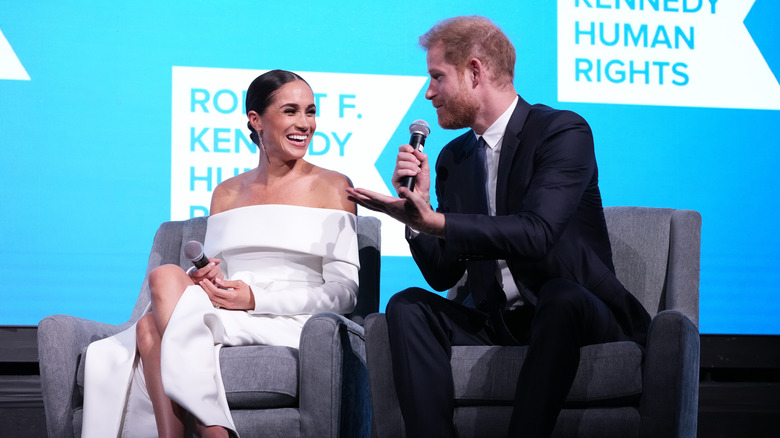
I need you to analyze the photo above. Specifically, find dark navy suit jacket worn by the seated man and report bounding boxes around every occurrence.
[409,98,650,344]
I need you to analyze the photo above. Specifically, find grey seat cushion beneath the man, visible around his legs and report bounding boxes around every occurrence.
[450,342,642,407]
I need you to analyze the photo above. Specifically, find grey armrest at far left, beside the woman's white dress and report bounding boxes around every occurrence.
[38,315,129,438]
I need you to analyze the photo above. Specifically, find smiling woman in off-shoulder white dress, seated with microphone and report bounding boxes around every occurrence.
[82,70,359,438]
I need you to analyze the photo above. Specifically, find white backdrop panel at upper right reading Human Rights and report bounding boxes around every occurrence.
[558,0,780,109]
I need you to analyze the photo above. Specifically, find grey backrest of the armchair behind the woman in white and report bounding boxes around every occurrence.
[126,216,381,324]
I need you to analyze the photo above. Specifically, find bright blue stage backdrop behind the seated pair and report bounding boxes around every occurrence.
[0,0,780,334]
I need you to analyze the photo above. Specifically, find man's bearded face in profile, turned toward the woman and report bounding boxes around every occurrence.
[425,42,479,129]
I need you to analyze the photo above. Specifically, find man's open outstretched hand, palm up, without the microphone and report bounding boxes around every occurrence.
[347,186,444,237]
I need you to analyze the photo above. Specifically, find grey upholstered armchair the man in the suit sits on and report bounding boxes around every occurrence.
[366,207,701,438]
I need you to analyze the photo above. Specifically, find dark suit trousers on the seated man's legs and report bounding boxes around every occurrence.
[386,279,627,437]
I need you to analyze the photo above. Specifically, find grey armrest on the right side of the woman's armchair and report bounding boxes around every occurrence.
[299,313,371,438]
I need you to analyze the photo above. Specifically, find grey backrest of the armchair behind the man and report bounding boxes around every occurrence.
[604,207,701,327]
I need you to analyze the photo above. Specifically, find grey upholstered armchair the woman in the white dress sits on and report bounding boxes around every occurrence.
[38,216,380,438]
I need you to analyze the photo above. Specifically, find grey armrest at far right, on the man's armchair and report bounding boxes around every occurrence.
[640,310,699,437]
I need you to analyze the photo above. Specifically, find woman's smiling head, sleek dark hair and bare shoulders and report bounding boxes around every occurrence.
[204,70,354,215]
